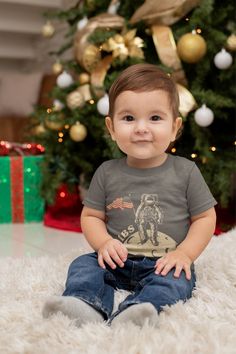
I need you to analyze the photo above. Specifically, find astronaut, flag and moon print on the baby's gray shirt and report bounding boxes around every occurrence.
[107,194,177,257]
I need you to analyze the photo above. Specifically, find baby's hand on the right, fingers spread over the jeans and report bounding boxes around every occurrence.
[155,249,192,280]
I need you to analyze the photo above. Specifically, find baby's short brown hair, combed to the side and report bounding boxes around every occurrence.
[109,64,179,119]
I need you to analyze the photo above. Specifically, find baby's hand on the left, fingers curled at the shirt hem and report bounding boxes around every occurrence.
[98,239,128,269]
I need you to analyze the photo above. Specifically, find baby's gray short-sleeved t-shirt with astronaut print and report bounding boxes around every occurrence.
[83,155,217,257]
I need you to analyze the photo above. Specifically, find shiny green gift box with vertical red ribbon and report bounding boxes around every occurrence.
[0,156,44,223]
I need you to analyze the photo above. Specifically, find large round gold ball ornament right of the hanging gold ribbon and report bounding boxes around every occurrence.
[177,33,207,64]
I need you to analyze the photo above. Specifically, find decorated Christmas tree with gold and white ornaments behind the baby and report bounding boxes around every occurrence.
[32,0,236,206]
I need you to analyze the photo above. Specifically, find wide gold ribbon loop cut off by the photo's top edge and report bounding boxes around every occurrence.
[130,0,200,26]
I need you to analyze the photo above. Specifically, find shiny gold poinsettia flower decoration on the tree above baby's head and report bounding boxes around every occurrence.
[102,29,144,60]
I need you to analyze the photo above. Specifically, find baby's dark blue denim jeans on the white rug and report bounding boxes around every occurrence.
[63,252,196,319]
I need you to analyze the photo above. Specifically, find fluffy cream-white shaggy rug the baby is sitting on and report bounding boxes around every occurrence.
[0,229,236,354]
